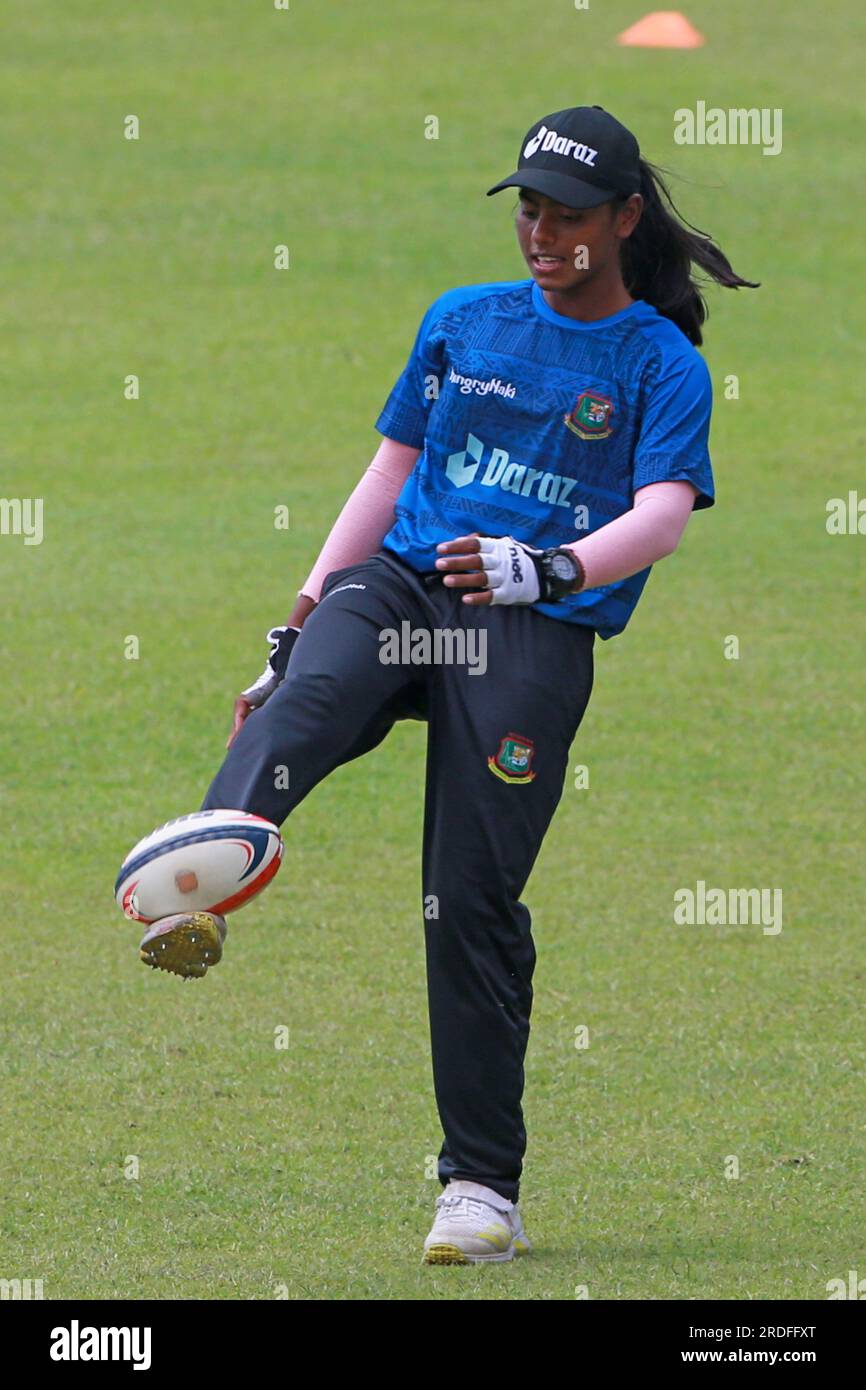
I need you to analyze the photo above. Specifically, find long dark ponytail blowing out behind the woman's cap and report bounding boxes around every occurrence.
[613,160,759,348]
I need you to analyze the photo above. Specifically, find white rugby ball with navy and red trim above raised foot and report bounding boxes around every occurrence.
[114,810,282,922]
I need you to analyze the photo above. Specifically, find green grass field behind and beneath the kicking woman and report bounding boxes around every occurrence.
[0,0,866,1300]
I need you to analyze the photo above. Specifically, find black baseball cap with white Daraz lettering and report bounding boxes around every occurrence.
[487,106,641,207]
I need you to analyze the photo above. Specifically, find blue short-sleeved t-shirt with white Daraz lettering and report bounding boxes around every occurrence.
[377,279,713,638]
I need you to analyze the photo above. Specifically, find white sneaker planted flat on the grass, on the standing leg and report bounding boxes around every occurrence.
[423,1179,532,1265]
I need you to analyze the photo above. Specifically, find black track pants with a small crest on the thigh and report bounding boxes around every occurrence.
[203,552,595,1201]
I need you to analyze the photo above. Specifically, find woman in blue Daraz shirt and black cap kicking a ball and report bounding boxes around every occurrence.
[140,106,751,1264]
